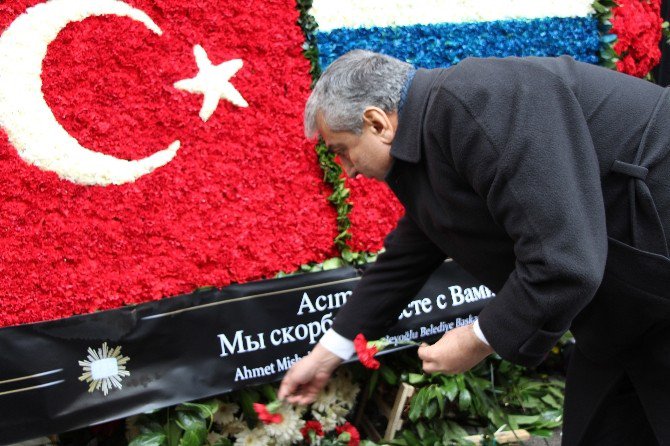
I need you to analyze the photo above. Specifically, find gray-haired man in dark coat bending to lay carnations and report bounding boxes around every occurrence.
[279,51,670,445]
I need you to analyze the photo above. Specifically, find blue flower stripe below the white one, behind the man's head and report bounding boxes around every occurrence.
[316,17,600,68]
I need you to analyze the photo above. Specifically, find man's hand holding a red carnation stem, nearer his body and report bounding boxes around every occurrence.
[418,325,493,374]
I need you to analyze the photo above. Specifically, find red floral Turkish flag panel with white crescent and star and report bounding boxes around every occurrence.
[0,0,337,326]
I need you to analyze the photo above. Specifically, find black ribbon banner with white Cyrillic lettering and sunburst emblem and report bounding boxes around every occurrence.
[0,262,493,444]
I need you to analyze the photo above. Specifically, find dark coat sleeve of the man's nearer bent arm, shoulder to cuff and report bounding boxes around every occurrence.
[428,59,607,366]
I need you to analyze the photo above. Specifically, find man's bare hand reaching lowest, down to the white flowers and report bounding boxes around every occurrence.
[277,344,342,404]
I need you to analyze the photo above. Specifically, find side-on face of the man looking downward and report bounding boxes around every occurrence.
[317,110,395,181]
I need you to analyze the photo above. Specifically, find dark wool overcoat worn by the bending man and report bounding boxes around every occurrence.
[333,57,670,365]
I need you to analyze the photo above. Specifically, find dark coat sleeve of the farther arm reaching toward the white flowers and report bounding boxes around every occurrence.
[333,215,446,339]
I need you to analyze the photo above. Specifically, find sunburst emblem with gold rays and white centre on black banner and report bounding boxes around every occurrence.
[79,342,130,396]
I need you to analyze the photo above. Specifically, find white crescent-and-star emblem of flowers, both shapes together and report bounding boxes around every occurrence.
[0,0,248,186]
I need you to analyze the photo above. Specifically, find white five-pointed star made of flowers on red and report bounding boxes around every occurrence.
[174,45,249,122]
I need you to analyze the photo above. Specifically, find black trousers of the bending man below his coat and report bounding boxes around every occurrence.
[562,324,670,446]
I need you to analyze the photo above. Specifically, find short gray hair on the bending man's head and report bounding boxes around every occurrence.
[305,50,412,138]
